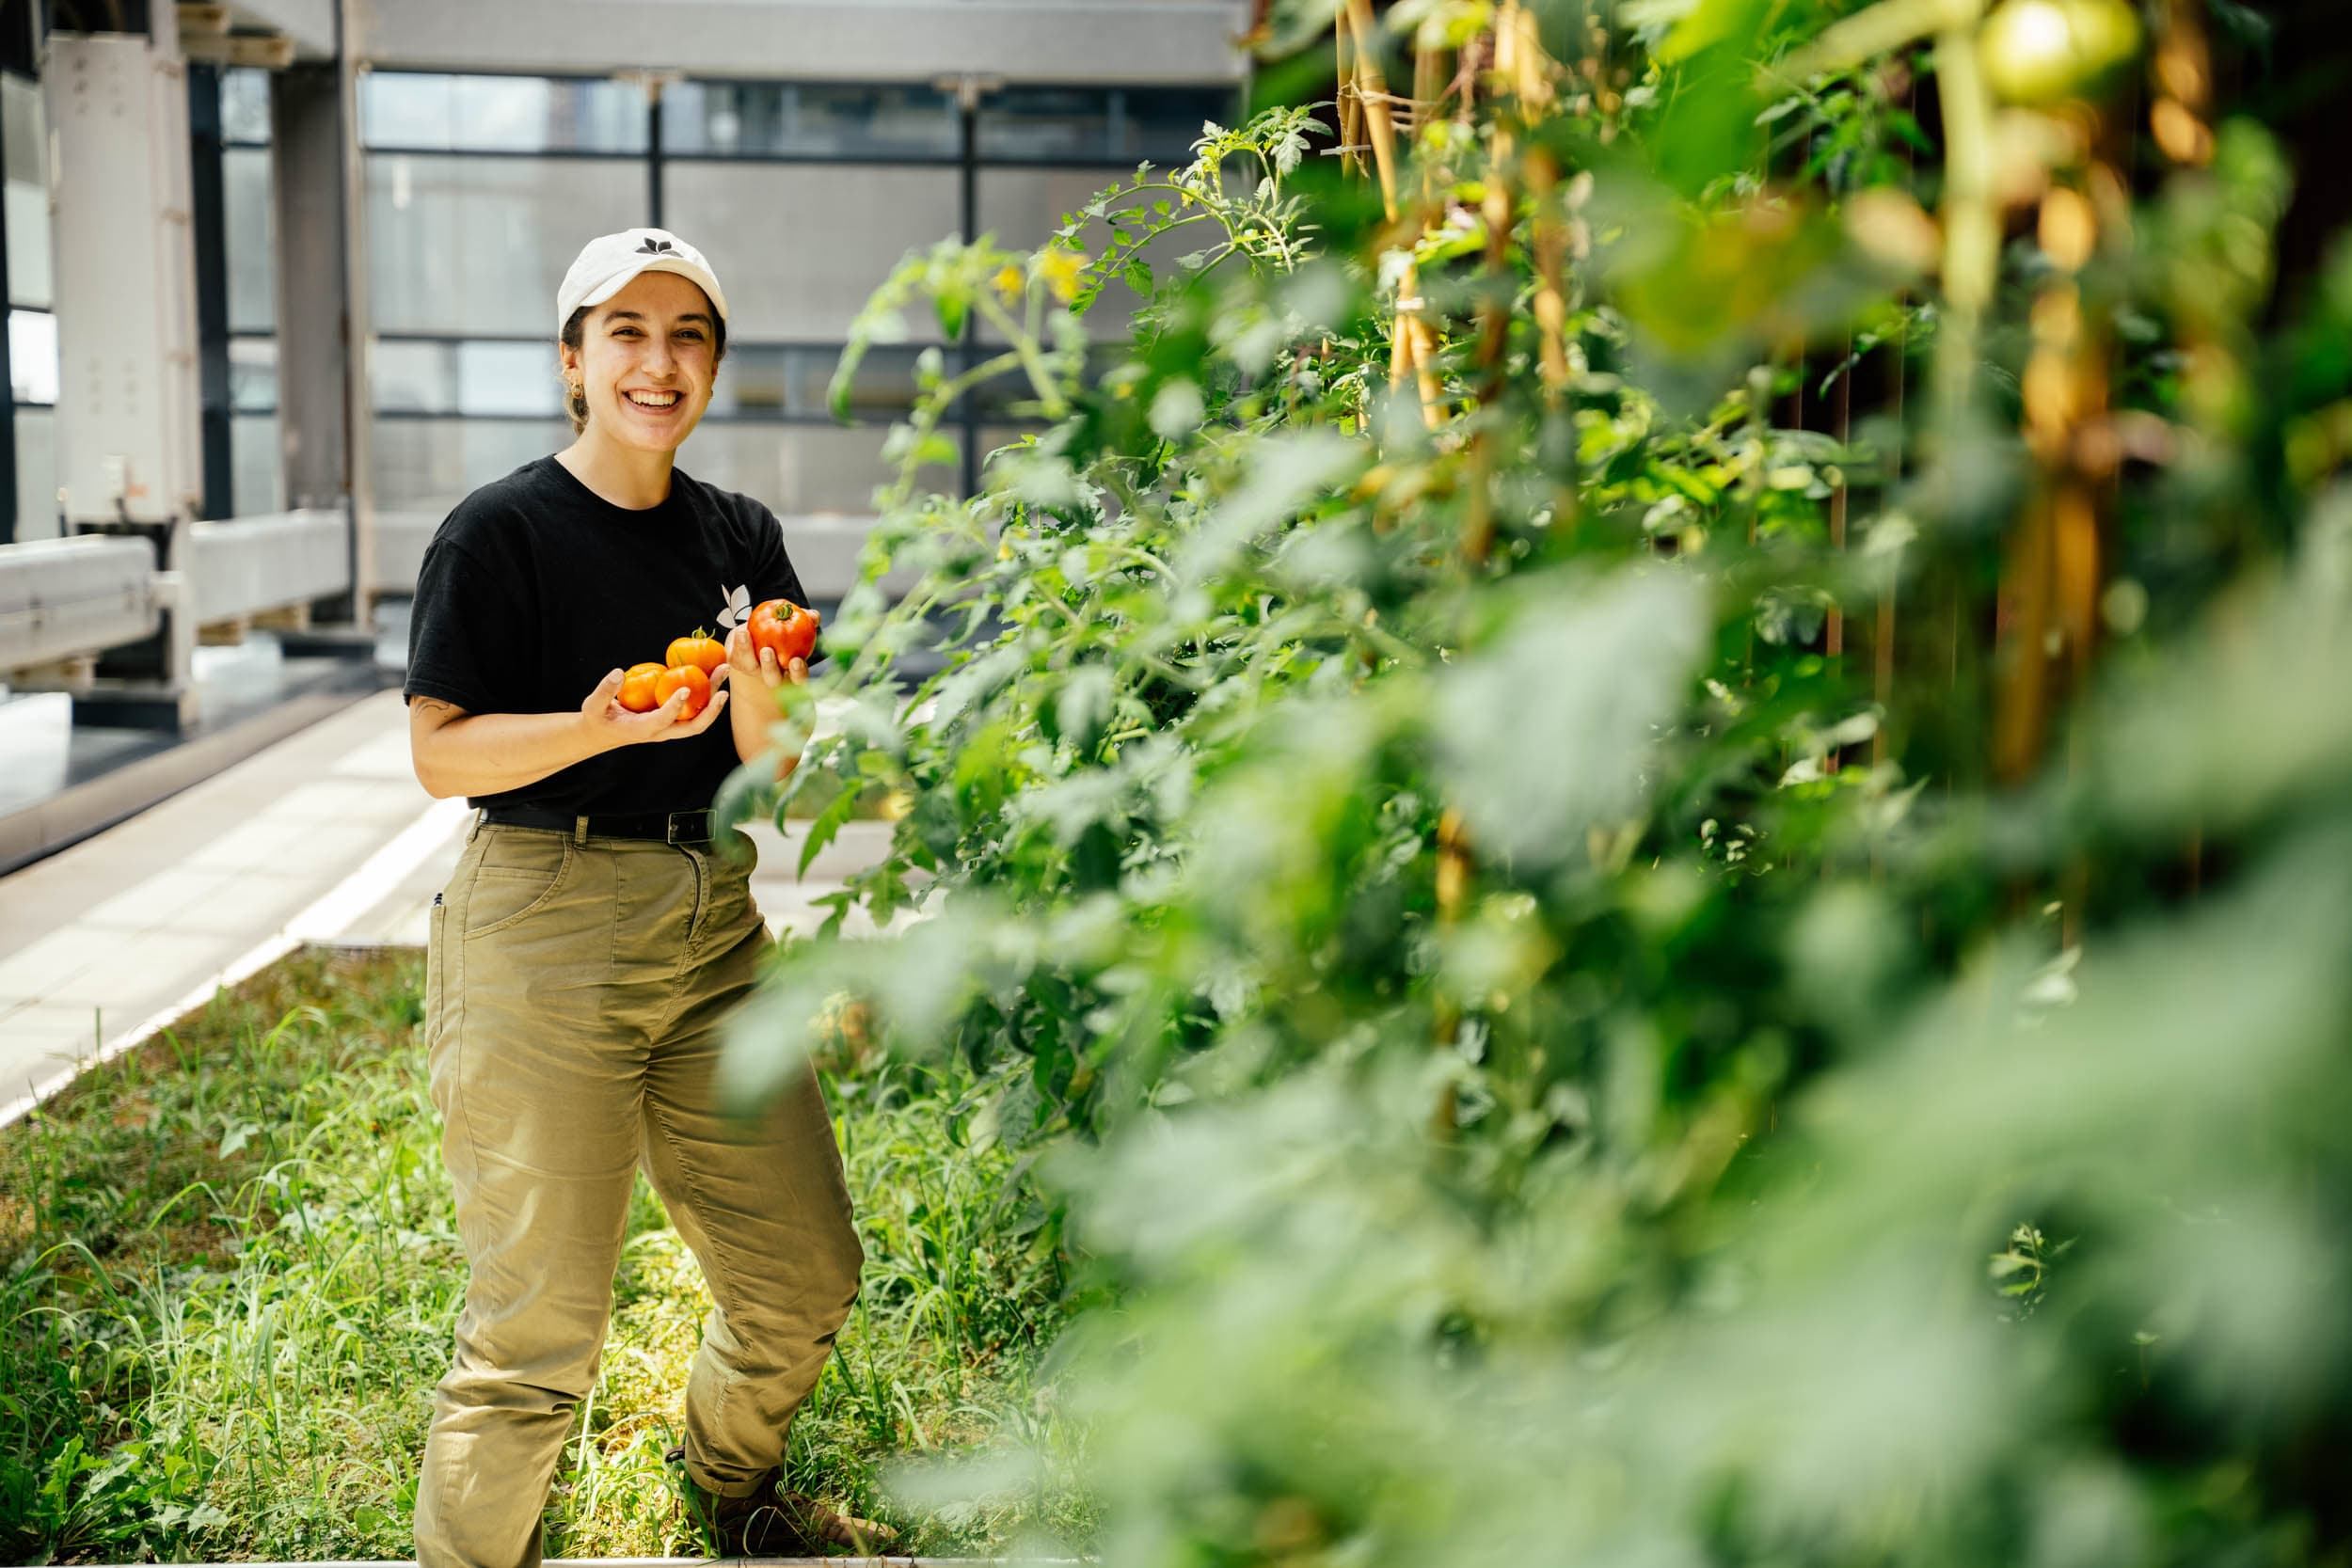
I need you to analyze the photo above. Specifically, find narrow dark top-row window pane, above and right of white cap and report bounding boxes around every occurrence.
[661,82,960,157]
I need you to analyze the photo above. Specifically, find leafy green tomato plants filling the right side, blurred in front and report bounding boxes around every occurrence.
[729,2,2352,1566]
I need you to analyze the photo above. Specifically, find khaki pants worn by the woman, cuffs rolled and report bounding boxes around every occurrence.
[417,820,864,1568]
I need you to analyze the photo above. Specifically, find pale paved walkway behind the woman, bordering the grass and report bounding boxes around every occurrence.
[0,691,889,1123]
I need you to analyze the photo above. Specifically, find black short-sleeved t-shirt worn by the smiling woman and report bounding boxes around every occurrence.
[403,456,823,816]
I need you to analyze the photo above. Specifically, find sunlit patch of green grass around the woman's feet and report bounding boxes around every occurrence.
[0,952,1091,1561]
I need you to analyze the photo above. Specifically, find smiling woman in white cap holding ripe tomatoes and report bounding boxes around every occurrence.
[405,228,889,1568]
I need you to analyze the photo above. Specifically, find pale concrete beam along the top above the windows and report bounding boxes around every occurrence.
[345,0,1249,82]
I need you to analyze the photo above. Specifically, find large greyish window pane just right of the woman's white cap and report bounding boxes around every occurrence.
[663,162,960,343]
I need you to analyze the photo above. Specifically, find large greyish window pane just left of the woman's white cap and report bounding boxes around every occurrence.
[367,152,649,338]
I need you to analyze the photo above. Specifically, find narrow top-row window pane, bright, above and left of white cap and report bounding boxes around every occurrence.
[360,71,647,152]
